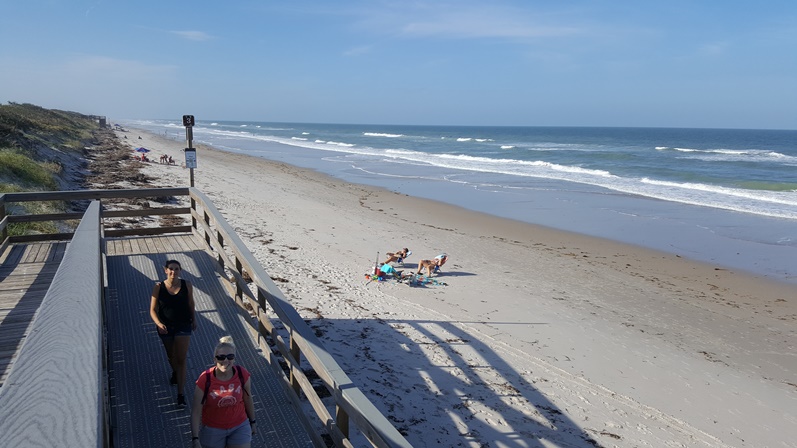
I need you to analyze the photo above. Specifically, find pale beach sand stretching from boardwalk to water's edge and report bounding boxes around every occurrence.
[117,130,797,447]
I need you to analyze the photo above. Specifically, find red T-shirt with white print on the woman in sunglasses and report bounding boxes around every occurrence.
[196,366,249,429]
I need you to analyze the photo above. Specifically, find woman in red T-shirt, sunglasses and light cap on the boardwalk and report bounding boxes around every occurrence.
[191,336,257,448]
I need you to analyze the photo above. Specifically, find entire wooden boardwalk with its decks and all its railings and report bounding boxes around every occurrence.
[0,187,411,448]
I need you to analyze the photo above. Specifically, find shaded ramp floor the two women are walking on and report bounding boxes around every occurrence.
[106,234,313,447]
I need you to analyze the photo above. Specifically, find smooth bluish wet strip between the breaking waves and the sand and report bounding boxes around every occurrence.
[145,121,797,284]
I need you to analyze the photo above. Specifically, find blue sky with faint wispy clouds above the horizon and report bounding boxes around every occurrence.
[0,0,797,129]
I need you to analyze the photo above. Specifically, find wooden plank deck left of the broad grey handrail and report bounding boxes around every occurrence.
[0,241,67,387]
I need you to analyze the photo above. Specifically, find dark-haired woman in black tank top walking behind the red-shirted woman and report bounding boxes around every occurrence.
[149,260,196,406]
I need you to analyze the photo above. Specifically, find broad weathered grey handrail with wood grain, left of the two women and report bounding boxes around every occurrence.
[0,201,108,447]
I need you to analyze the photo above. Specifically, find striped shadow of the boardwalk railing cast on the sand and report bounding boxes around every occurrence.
[309,318,601,447]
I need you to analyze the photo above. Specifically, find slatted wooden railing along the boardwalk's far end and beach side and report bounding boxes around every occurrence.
[0,187,411,447]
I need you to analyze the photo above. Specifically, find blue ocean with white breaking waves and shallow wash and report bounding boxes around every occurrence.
[120,120,797,283]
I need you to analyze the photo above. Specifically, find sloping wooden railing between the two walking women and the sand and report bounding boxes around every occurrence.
[190,187,411,447]
